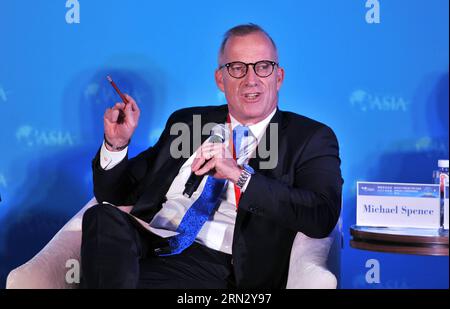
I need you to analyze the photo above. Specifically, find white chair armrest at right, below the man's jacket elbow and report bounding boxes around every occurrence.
[286,232,337,289]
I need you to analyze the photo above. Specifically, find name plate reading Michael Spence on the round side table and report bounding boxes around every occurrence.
[356,182,440,228]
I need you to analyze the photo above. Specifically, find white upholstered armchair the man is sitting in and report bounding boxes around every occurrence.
[6,198,340,289]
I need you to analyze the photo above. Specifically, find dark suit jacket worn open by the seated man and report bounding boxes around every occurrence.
[93,105,343,288]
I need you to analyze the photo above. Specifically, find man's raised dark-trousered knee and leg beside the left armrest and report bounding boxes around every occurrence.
[81,204,153,288]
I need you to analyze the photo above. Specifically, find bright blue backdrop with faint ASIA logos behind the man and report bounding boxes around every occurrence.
[0,0,449,288]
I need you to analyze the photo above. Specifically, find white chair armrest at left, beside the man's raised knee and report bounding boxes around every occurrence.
[6,198,97,289]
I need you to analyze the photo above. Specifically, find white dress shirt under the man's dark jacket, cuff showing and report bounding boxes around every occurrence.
[100,109,276,254]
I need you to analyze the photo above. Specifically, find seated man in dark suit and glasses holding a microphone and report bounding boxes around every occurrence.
[81,24,342,288]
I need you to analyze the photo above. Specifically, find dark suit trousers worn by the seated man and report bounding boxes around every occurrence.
[80,204,234,288]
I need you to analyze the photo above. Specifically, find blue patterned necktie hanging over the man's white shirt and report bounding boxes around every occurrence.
[156,126,248,256]
